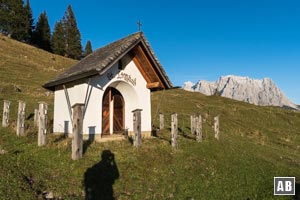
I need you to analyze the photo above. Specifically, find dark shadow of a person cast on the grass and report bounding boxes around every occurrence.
[83,150,120,200]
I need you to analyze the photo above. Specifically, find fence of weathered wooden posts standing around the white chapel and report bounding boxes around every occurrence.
[2,100,220,160]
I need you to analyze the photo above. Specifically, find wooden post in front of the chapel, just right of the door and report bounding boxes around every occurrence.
[132,109,142,147]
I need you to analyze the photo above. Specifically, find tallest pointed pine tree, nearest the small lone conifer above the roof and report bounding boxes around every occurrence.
[63,5,82,59]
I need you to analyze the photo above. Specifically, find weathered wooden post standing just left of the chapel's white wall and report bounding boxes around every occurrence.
[38,102,48,147]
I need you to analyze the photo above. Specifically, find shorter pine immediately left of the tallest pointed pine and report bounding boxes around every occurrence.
[51,21,66,56]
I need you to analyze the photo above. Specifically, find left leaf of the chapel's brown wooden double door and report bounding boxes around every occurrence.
[102,89,111,135]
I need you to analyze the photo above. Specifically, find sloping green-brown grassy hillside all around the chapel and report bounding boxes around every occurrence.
[0,37,300,200]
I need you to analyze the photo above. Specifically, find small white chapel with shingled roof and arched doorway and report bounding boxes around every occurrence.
[43,32,172,140]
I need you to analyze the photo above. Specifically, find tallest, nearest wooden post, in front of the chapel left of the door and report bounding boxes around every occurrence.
[72,103,84,160]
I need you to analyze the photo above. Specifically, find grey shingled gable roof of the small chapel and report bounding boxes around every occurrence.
[43,32,172,90]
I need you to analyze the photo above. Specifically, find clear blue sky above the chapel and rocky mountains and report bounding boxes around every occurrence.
[30,0,300,104]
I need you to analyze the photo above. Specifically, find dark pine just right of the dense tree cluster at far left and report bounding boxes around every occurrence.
[33,11,51,51]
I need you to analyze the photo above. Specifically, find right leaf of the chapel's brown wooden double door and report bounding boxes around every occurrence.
[112,89,124,133]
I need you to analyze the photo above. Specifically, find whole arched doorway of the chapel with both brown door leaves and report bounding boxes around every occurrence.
[102,87,125,135]
